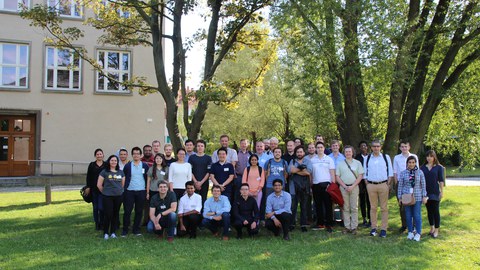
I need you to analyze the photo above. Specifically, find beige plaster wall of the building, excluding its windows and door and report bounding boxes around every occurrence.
[0,1,165,175]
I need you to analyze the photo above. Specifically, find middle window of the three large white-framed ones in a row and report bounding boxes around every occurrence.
[45,47,81,91]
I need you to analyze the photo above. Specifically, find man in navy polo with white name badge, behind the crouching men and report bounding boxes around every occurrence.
[210,147,235,201]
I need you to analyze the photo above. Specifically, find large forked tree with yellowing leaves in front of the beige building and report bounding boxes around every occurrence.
[22,0,271,149]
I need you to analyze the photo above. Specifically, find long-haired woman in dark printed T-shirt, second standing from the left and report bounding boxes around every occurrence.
[97,155,125,240]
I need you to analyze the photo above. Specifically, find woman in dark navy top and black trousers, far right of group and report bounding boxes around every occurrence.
[420,150,444,238]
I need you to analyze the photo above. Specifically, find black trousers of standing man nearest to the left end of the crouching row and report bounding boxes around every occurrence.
[123,190,147,233]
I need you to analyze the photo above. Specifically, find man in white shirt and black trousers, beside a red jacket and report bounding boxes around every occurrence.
[310,142,335,233]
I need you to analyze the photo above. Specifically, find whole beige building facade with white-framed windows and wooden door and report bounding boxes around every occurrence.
[0,0,165,176]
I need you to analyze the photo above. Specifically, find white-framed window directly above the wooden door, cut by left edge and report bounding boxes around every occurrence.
[0,43,29,89]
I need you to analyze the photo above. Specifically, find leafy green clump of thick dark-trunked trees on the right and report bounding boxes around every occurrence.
[273,0,480,157]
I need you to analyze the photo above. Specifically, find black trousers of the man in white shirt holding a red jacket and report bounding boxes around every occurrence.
[312,183,333,227]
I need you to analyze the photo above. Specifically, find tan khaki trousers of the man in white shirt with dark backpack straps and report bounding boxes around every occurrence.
[367,182,389,231]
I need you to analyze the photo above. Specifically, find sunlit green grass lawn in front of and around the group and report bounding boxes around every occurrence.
[0,187,480,269]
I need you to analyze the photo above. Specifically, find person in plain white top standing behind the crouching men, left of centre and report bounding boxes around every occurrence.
[168,148,192,200]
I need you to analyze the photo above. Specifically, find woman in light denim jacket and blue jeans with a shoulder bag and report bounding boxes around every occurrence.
[397,156,428,242]
